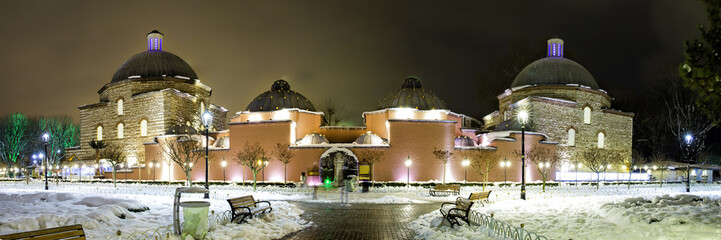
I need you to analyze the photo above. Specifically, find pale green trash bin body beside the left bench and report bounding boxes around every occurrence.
[180,201,210,239]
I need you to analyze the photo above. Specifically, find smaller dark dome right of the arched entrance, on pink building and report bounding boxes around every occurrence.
[378,77,446,110]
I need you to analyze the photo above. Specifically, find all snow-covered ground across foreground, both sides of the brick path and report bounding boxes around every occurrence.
[0,181,721,239]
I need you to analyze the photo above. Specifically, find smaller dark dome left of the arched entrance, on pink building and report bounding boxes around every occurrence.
[245,80,315,112]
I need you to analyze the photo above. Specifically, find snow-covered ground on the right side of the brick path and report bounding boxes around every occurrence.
[411,184,721,239]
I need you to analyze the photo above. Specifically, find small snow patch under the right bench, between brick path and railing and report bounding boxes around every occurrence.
[410,211,493,240]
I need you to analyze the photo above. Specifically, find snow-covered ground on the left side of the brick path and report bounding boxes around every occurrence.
[0,182,311,239]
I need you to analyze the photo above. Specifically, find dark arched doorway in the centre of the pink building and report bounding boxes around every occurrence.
[319,147,358,186]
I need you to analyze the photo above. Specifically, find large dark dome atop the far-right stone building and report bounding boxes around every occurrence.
[511,57,598,89]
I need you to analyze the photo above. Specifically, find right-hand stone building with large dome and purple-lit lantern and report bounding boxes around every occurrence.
[483,38,634,169]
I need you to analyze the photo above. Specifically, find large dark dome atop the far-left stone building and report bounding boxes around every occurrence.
[110,51,198,82]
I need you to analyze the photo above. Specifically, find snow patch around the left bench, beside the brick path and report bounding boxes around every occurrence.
[208,202,312,240]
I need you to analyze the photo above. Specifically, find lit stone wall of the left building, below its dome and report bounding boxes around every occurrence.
[70,80,227,166]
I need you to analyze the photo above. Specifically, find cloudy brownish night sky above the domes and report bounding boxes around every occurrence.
[0,0,706,124]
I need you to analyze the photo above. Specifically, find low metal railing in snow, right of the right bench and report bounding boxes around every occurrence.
[468,210,548,240]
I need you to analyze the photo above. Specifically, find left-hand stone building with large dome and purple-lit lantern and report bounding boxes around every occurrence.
[70,31,227,166]
